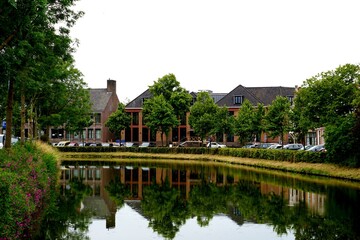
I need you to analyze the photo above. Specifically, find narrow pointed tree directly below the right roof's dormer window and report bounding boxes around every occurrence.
[235,99,255,144]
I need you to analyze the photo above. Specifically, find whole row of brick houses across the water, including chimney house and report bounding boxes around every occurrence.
[45,79,323,146]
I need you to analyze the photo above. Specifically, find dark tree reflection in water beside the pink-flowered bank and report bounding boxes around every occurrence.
[36,179,92,240]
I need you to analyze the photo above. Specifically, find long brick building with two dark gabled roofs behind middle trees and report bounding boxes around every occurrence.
[122,85,296,146]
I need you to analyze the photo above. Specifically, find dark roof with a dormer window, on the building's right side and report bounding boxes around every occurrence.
[217,85,295,108]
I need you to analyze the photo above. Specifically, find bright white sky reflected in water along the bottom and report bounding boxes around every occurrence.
[88,204,295,240]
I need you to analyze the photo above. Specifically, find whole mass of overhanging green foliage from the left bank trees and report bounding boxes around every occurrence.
[0,0,89,148]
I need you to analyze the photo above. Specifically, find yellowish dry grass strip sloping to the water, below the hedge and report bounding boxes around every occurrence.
[61,151,360,181]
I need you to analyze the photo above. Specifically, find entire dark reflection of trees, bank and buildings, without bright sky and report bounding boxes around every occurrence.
[45,162,360,239]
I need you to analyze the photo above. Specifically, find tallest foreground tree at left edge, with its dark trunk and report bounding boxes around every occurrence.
[0,0,82,148]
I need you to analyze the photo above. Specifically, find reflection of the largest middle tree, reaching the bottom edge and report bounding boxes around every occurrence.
[141,179,189,239]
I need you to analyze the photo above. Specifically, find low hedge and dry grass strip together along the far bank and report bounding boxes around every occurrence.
[61,147,360,181]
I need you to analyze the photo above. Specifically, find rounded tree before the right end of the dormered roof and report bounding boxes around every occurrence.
[265,96,290,144]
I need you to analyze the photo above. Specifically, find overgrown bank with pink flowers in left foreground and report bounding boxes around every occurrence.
[0,143,59,239]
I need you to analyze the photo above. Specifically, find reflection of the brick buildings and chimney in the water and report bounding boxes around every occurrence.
[60,166,325,228]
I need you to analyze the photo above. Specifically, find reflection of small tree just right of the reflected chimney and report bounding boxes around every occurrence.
[105,176,131,208]
